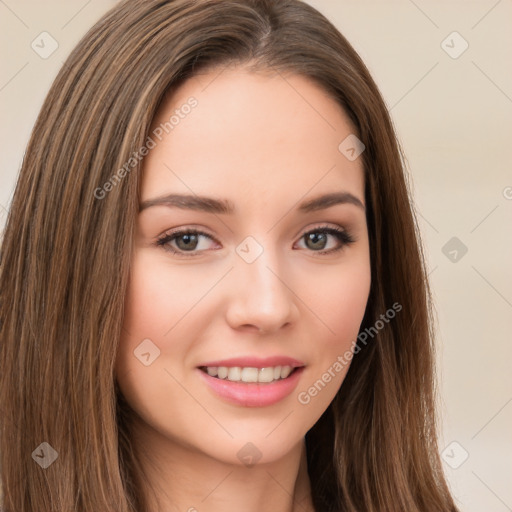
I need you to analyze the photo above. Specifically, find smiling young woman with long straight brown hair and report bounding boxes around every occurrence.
[0,0,457,512]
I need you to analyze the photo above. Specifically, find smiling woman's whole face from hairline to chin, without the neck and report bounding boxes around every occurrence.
[116,68,370,464]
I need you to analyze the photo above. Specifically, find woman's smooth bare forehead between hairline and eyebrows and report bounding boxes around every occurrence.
[142,68,364,208]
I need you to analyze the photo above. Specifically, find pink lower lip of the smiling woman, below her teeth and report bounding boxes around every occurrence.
[197,367,304,407]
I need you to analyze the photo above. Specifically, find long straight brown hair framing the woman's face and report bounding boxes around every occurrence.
[0,0,457,512]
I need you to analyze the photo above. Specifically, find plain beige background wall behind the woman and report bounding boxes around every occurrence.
[0,0,512,512]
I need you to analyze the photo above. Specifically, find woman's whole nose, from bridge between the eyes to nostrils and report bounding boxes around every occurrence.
[228,237,297,331]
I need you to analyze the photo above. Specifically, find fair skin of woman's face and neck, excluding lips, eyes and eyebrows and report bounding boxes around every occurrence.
[116,67,371,512]
